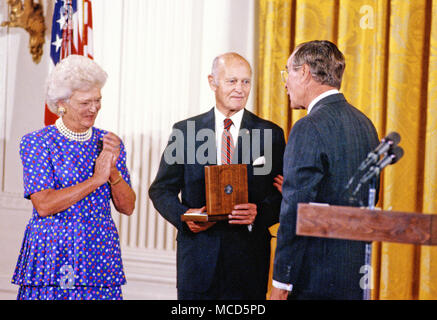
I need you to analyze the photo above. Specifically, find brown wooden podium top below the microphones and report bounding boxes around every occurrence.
[296,203,437,245]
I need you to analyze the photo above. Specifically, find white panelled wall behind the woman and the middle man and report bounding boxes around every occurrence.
[0,0,256,299]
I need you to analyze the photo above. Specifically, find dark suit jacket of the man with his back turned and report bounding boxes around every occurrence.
[274,94,378,299]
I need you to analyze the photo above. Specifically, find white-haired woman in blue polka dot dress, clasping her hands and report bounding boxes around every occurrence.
[12,55,135,300]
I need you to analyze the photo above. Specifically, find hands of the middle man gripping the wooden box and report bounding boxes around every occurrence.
[185,203,258,233]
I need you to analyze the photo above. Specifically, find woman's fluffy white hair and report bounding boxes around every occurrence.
[46,55,108,114]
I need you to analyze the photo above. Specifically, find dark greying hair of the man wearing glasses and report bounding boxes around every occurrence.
[292,40,346,89]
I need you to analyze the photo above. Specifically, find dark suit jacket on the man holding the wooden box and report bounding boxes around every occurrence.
[149,109,285,298]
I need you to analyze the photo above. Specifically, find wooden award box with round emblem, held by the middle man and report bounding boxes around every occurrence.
[181,164,249,222]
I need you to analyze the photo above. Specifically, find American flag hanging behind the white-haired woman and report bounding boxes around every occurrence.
[44,0,93,126]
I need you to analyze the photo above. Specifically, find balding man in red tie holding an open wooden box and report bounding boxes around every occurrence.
[149,53,285,300]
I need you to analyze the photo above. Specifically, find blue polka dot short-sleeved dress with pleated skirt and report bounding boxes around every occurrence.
[12,126,130,300]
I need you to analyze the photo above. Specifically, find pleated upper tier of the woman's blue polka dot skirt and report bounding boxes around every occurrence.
[12,208,126,287]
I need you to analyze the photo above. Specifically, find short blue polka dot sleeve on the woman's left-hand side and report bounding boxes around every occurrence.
[20,133,55,199]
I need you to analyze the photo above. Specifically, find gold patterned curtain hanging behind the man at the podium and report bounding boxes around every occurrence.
[257,0,437,299]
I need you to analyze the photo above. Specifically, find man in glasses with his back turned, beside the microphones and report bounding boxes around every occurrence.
[271,41,378,299]
